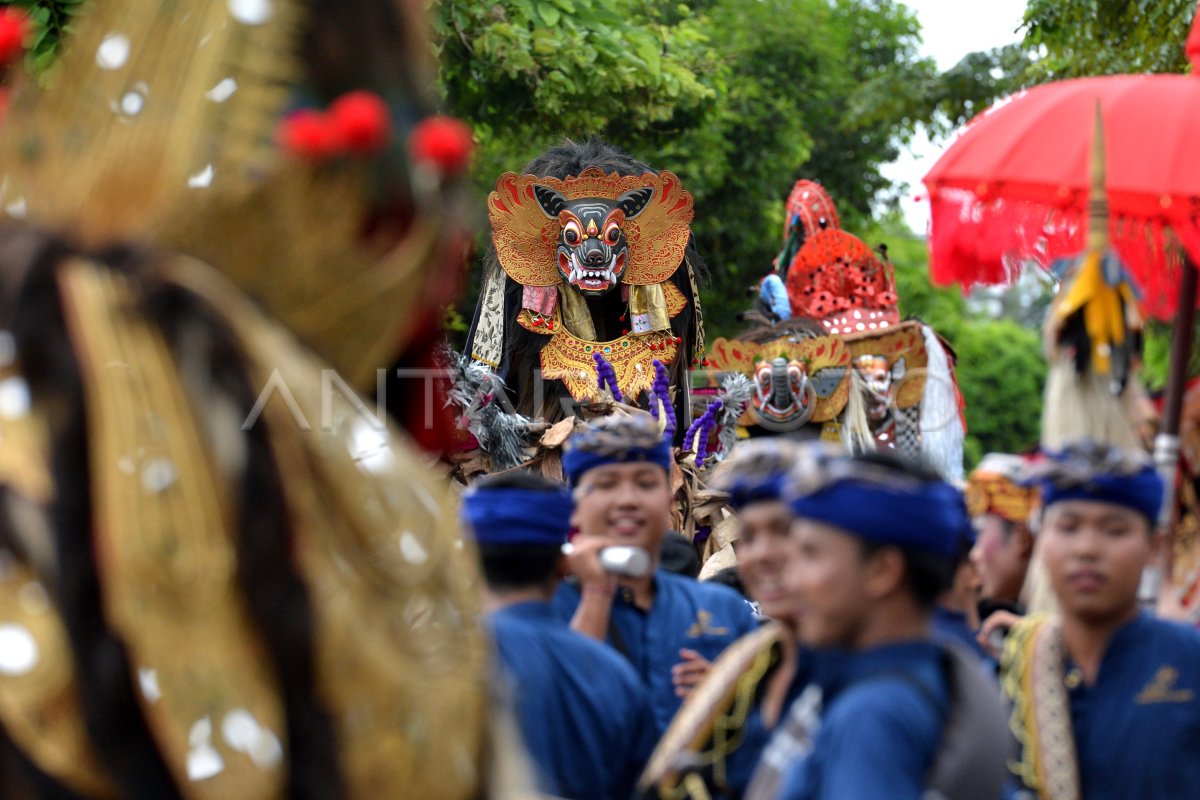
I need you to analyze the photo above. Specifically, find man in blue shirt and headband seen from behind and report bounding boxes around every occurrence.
[462,473,658,800]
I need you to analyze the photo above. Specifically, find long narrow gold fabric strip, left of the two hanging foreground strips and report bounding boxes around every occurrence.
[60,261,287,799]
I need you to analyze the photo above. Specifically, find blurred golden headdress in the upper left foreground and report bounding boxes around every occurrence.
[0,0,444,386]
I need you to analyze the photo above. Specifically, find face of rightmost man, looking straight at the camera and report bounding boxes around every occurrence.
[1038,500,1153,622]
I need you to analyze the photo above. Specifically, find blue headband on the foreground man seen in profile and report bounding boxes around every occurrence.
[791,479,971,557]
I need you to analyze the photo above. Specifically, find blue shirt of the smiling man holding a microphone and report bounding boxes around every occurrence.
[554,570,758,735]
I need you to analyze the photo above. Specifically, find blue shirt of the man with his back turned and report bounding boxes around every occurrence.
[490,602,658,800]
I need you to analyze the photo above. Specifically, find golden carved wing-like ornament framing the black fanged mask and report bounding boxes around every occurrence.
[487,167,695,287]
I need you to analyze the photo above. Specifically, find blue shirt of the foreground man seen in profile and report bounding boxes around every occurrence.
[779,642,950,800]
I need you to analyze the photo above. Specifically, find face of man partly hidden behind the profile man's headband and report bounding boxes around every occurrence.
[733,500,799,625]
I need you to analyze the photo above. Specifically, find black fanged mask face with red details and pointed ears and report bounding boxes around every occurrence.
[534,186,654,295]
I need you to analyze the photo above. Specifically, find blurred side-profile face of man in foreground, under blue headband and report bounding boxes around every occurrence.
[792,519,869,646]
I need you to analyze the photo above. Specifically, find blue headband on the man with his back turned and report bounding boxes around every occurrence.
[462,487,575,546]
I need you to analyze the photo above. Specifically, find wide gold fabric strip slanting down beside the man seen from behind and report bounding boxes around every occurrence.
[172,263,486,798]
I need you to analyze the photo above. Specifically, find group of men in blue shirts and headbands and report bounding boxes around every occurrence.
[463,417,1200,800]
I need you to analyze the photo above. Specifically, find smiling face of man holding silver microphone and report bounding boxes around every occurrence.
[572,463,673,554]
